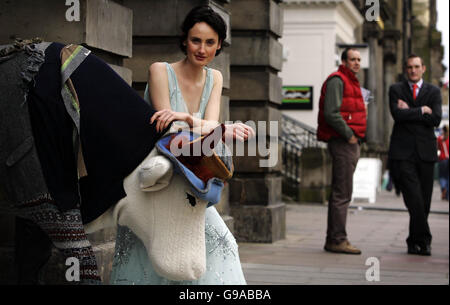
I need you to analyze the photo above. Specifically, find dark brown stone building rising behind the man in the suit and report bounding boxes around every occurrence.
[352,0,445,152]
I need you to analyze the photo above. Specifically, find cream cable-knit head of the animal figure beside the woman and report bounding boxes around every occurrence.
[85,144,207,281]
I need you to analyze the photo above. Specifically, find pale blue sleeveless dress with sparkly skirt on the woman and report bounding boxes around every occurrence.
[110,63,246,285]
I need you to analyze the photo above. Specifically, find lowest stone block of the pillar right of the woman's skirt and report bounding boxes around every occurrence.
[231,203,286,243]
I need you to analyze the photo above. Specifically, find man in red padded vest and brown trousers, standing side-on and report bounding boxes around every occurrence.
[317,48,367,254]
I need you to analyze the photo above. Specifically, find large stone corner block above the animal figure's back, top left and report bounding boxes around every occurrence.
[0,0,133,57]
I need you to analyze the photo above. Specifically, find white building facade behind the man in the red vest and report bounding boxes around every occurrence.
[281,0,369,129]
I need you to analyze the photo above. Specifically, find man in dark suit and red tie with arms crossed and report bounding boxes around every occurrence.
[389,55,442,255]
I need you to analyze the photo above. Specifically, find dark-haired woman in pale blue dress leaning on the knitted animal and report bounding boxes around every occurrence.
[110,6,254,285]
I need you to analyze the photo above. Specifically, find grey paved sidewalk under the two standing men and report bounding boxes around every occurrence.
[239,182,449,285]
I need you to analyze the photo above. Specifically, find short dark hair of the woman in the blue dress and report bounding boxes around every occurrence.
[180,5,227,56]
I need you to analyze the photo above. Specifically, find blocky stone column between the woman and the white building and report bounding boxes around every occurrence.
[229,0,286,242]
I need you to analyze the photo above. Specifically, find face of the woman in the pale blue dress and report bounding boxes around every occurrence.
[185,22,221,66]
